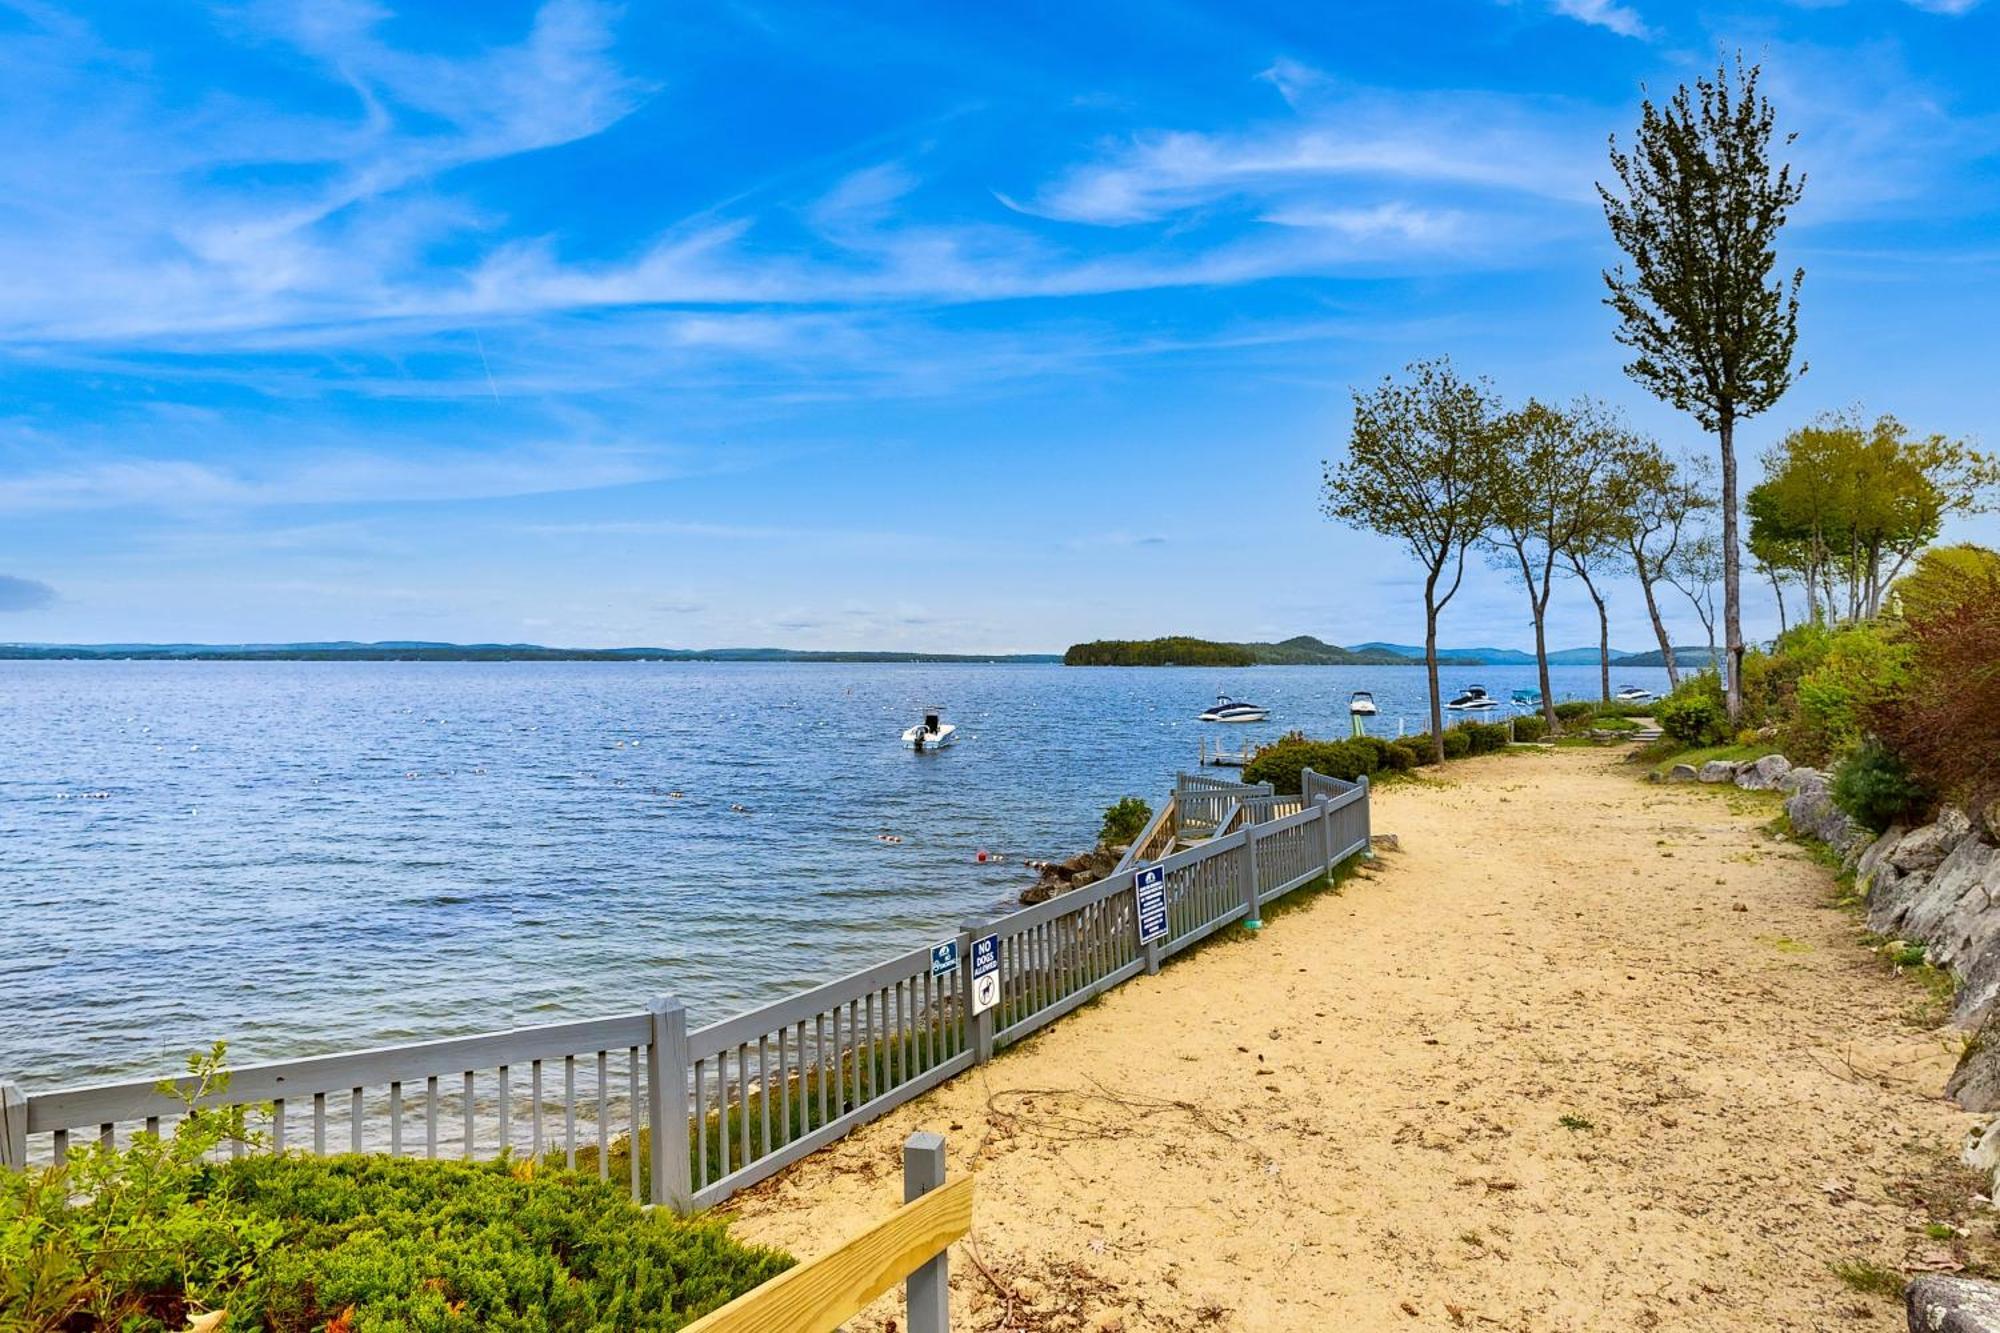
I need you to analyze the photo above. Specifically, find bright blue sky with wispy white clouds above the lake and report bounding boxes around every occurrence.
[0,0,2000,650]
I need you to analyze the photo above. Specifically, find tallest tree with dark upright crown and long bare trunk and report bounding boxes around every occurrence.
[1598,56,1806,723]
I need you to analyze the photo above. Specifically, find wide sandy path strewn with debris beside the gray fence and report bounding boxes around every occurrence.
[732,751,1970,1329]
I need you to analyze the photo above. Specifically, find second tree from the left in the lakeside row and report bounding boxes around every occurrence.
[1484,398,1618,729]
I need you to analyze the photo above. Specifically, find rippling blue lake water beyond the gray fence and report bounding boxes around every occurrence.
[0,662,1666,1089]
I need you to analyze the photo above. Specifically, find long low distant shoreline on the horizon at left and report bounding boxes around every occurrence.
[0,640,1062,662]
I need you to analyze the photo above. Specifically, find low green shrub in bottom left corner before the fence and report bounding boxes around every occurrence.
[0,1045,790,1333]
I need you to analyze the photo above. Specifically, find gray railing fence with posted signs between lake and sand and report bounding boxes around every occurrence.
[0,769,1370,1211]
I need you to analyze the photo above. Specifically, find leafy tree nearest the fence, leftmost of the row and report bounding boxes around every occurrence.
[1322,358,1500,763]
